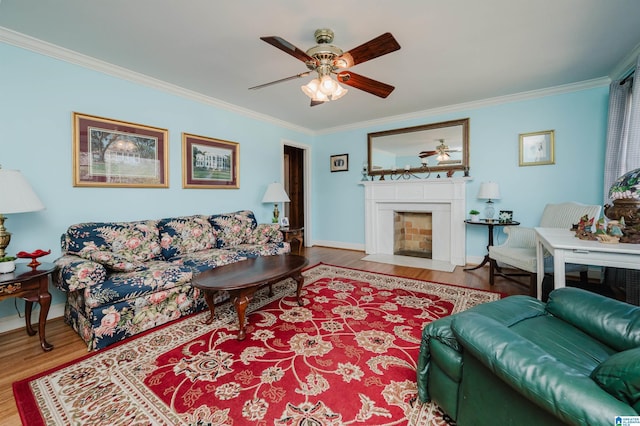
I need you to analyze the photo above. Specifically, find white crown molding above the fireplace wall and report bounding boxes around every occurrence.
[317,77,611,135]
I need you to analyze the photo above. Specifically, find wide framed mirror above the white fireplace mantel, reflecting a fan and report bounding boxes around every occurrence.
[368,118,469,175]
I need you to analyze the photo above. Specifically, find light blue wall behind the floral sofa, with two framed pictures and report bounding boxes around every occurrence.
[0,43,312,318]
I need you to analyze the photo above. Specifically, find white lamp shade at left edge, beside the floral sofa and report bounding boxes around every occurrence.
[0,169,44,214]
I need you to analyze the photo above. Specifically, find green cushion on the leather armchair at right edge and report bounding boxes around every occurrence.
[591,348,640,412]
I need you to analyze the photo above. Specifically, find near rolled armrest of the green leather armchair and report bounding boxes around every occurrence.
[452,313,638,425]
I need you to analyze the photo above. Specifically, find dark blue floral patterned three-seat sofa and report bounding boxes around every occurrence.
[54,210,290,350]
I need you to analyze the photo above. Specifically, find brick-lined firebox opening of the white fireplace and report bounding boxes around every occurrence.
[393,212,433,259]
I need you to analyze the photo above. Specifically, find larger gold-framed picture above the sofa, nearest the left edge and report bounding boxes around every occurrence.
[72,112,169,188]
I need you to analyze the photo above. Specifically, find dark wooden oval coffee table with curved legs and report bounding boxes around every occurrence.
[192,254,309,340]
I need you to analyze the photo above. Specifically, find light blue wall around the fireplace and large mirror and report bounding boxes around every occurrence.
[313,86,609,258]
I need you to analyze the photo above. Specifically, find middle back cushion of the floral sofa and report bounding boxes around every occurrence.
[158,215,218,259]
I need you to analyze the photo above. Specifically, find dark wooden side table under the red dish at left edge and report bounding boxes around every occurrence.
[0,263,56,352]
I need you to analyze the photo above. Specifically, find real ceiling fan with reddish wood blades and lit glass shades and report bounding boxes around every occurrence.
[249,28,400,106]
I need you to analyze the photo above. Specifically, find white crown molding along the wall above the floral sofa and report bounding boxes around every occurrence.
[0,27,314,135]
